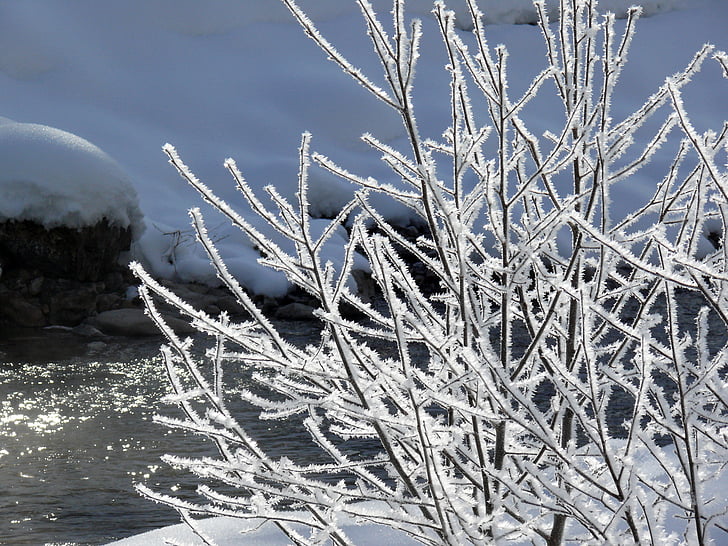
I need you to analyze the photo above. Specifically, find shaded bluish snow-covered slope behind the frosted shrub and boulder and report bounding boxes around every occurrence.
[0,0,728,295]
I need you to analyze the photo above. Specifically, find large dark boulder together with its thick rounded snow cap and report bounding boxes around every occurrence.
[0,118,144,281]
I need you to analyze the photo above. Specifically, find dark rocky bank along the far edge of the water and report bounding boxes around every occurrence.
[0,214,436,336]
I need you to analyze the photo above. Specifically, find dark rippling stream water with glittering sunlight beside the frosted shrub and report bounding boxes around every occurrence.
[0,326,324,545]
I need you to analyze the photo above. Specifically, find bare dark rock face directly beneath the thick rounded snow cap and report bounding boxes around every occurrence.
[0,219,132,281]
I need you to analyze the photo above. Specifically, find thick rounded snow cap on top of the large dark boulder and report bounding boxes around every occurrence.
[0,118,144,238]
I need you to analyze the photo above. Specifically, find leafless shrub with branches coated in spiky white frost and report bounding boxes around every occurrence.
[135,0,728,544]
